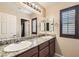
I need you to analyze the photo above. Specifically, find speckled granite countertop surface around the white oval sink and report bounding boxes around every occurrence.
[0,35,55,57]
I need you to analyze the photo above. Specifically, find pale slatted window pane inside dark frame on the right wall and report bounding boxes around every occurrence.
[62,9,75,35]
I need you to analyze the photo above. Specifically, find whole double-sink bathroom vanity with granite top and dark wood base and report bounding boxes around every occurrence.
[0,35,56,57]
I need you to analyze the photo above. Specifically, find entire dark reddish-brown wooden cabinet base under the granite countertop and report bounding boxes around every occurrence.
[15,38,55,57]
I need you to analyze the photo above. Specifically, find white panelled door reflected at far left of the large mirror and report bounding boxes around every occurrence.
[0,12,16,38]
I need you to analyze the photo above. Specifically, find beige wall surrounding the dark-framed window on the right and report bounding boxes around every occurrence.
[46,2,79,56]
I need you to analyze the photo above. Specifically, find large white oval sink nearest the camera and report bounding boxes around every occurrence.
[4,41,32,52]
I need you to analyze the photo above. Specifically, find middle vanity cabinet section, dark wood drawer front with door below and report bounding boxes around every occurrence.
[39,41,49,57]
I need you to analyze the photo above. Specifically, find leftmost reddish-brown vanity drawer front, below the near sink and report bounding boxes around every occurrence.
[16,47,38,57]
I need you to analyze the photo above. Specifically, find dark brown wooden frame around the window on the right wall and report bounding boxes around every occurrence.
[60,5,79,38]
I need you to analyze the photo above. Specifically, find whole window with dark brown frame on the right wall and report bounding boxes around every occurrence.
[60,5,79,38]
